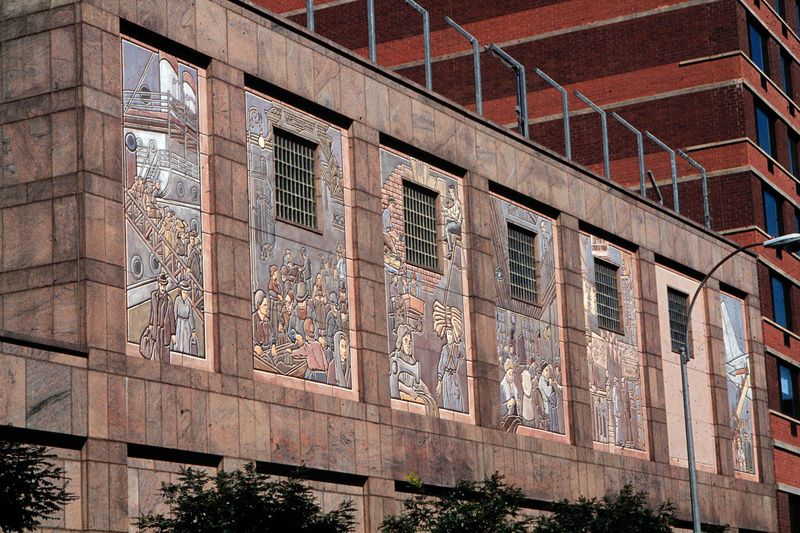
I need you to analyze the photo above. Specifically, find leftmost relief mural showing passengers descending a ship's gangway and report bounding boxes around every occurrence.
[122,40,206,364]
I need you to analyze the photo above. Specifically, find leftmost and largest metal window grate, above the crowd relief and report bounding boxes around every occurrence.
[275,130,317,229]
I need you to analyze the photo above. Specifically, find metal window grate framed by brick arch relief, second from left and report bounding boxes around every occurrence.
[403,183,439,270]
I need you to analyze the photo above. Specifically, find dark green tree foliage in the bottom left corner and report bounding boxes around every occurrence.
[0,440,76,531]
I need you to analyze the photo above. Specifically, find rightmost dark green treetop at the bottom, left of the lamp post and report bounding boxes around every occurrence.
[533,485,675,533]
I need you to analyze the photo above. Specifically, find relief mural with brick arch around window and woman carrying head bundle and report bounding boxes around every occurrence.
[381,149,472,416]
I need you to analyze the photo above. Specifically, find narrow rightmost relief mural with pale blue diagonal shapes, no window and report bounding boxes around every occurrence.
[720,294,756,474]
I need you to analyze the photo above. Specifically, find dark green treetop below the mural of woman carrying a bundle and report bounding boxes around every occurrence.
[381,472,531,533]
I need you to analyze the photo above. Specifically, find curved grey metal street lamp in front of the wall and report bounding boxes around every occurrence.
[680,233,800,533]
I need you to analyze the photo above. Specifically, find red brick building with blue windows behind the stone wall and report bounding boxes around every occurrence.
[262,0,800,532]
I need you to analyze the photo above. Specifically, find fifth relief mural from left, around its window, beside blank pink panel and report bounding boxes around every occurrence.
[581,234,646,451]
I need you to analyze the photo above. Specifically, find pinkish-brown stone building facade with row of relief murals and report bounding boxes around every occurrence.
[0,0,777,531]
